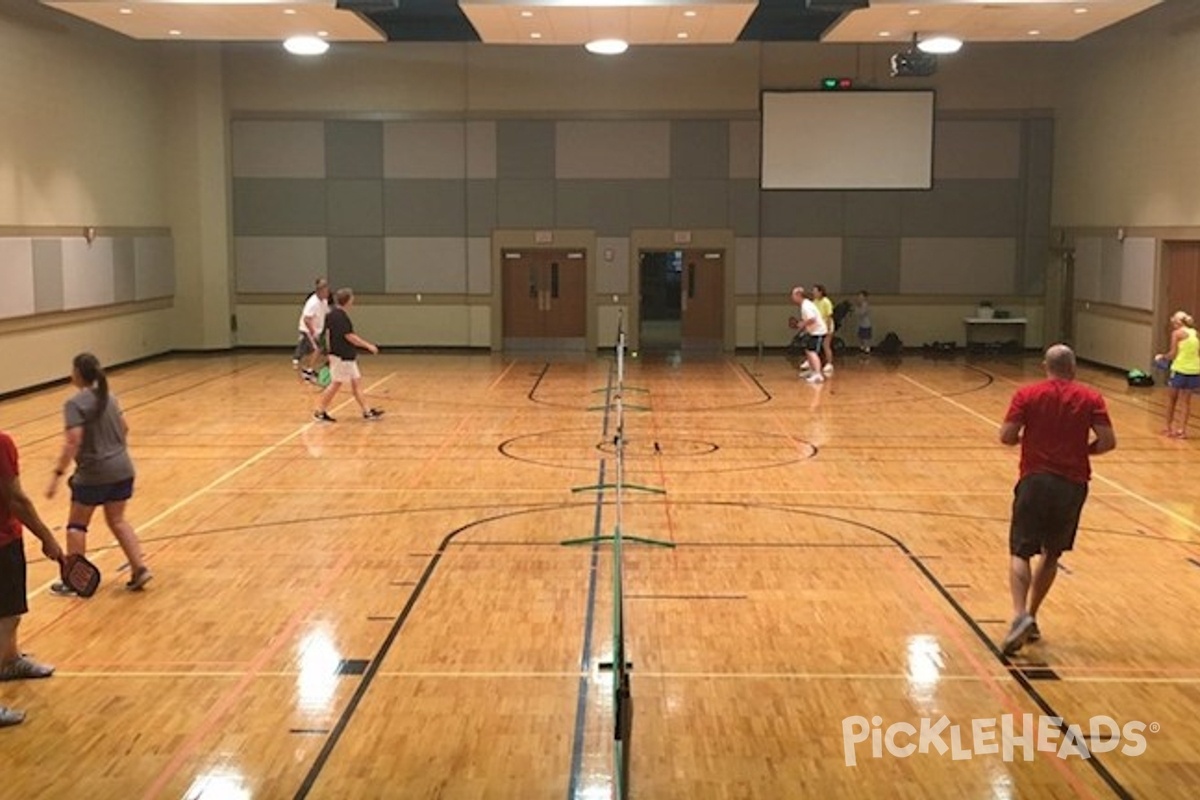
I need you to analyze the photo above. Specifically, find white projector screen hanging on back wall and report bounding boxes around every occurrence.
[761,91,934,190]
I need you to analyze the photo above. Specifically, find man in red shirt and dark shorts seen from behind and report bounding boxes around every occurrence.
[1000,344,1117,656]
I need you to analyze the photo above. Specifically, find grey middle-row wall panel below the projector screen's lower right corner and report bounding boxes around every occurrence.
[901,181,1021,237]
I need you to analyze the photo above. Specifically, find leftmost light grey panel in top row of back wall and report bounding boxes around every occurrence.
[229,120,325,178]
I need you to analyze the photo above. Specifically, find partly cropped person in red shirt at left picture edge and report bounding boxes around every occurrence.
[0,433,62,728]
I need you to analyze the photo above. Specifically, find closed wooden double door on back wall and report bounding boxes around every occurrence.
[500,248,588,350]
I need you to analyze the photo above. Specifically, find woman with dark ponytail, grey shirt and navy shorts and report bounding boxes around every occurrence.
[46,353,151,596]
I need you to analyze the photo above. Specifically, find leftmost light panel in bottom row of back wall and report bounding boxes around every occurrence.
[234,236,329,296]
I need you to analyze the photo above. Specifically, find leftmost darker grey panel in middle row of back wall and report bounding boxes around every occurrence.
[233,178,326,236]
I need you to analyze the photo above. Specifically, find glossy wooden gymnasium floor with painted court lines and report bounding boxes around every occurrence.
[0,353,1200,800]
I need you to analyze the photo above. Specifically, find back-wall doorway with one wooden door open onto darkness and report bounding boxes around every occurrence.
[637,248,725,351]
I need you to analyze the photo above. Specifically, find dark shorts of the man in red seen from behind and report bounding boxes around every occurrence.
[1008,473,1087,559]
